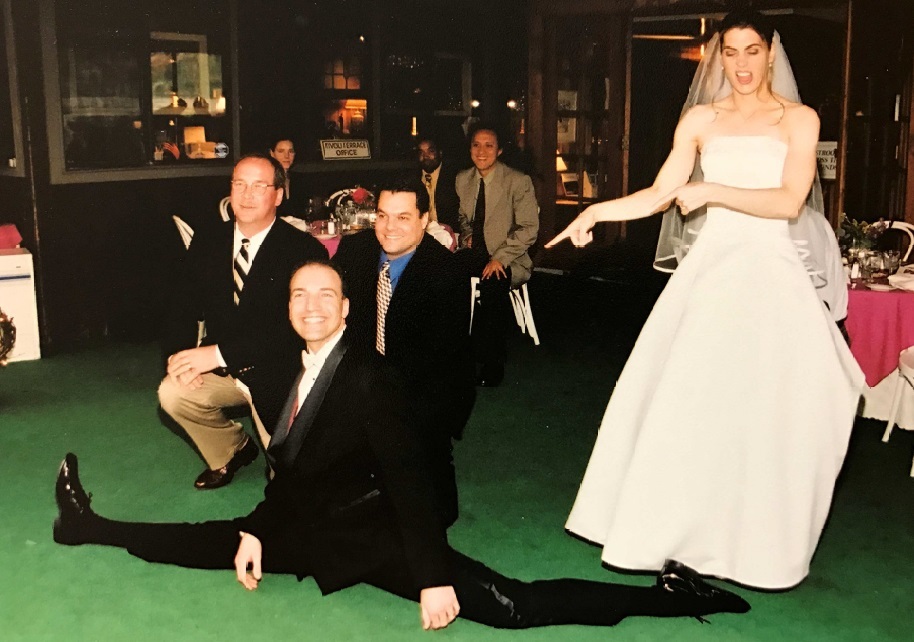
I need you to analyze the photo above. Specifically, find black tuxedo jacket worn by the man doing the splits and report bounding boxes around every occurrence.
[239,338,453,597]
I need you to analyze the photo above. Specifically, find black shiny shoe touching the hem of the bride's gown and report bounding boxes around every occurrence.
[657,560,751,621]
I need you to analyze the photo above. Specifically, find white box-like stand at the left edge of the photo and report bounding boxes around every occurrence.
[0,249,41,362]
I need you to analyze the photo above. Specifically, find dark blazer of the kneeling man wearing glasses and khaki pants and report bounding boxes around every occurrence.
[163,219,327,385]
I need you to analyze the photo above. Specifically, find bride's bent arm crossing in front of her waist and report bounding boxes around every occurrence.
[667,106,819,219]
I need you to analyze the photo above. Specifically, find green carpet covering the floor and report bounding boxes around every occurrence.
[0,274,914,641]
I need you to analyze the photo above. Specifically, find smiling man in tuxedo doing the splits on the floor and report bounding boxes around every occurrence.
[54,263,749,629]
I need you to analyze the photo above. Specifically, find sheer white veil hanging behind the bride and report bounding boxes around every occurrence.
[654,32,847,321]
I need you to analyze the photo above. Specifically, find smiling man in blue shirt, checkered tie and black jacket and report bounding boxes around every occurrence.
[333,177,476,525]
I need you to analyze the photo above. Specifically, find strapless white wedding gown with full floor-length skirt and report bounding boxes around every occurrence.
[566,136,864,589]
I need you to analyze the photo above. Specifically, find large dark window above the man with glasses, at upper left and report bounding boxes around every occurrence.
[42,0,235,182]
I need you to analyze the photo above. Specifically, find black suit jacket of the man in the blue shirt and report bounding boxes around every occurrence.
[333,230,476,438]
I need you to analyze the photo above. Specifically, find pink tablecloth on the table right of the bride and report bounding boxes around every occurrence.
[845,290,914,386]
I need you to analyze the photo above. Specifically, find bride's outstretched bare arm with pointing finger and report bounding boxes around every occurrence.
[546,108,706,248]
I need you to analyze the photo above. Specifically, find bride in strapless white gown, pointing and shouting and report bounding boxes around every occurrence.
[547,12,863,589]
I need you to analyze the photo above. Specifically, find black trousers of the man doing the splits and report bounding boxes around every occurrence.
[86,518,677,628]
